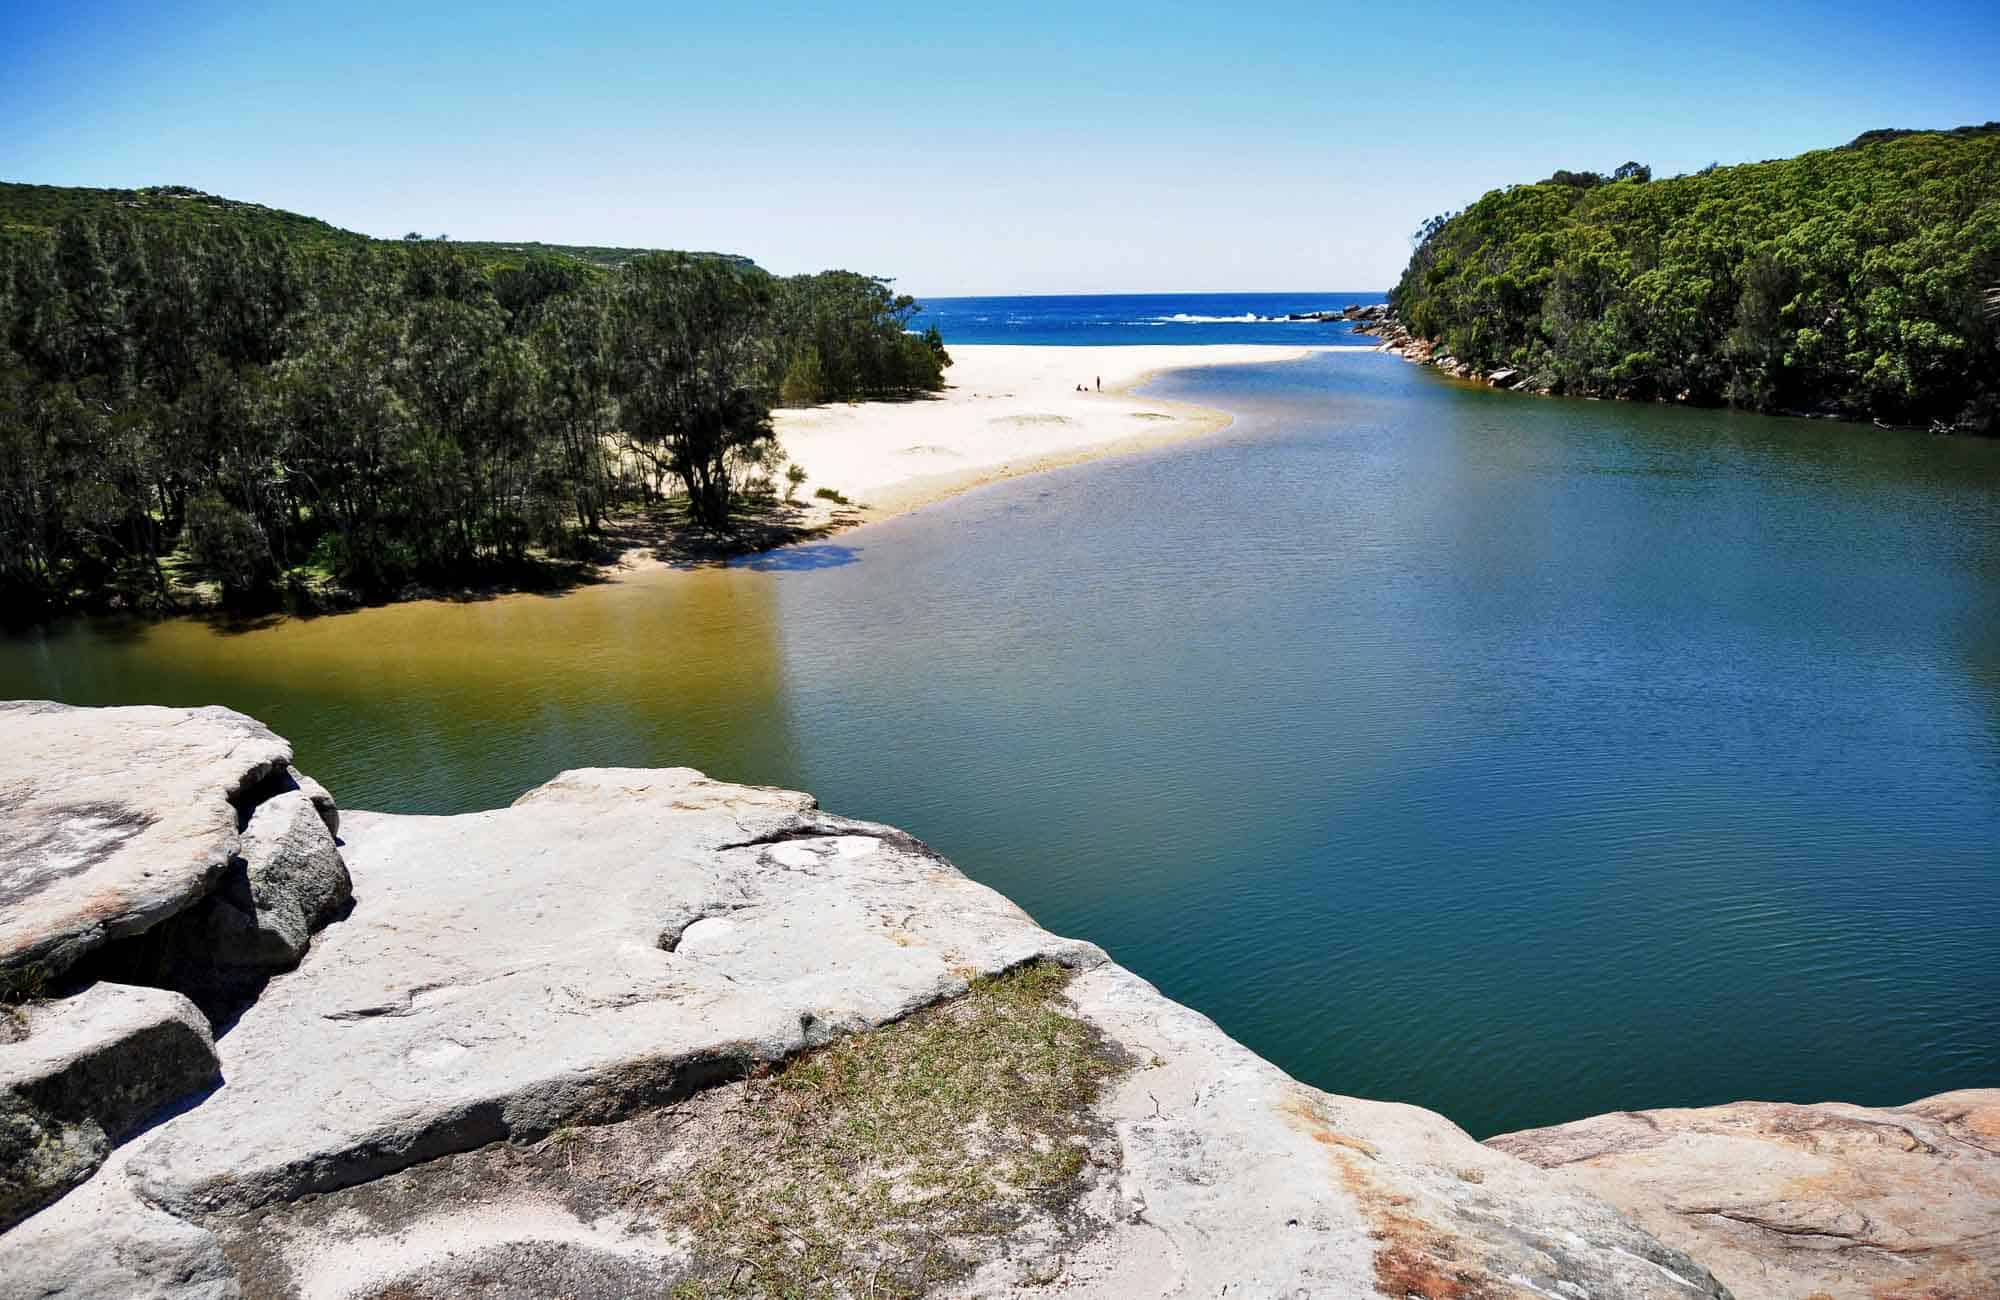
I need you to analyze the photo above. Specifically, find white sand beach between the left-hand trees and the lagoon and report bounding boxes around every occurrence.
[776,344,1316,518]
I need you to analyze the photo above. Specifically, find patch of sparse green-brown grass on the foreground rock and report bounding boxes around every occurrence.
[664,962,1124,1300]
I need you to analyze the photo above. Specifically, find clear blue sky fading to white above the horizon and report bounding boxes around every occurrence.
[0,0,2000,294]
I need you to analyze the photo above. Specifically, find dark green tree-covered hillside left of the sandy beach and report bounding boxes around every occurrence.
[0,186,950,618]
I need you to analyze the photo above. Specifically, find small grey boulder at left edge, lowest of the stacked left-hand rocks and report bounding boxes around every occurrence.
[0,984,216,1230]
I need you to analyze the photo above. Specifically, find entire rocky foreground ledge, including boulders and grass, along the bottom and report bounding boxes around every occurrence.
[0,704,2000,1300]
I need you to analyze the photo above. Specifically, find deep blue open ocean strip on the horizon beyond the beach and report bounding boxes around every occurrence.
[910,292,1384,346]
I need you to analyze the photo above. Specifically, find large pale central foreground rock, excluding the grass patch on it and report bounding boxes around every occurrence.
[0,770,1726,1300]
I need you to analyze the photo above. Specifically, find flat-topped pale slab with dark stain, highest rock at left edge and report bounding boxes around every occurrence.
[0,700,292,990]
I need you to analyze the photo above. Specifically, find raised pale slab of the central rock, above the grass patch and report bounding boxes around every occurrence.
[130,770,1102,1214]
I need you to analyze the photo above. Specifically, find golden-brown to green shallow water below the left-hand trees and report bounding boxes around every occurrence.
[0,570,792,812]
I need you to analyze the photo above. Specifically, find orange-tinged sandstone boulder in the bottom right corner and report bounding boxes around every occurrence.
[1488,1088,2000,1300]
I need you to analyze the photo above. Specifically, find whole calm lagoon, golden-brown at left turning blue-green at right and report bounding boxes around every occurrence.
[0,340,2000,1136]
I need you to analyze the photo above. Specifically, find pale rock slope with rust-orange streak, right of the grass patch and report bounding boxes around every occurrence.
[992,962,1728,1300]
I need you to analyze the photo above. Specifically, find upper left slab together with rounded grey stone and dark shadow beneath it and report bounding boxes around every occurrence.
[0,700,348,994]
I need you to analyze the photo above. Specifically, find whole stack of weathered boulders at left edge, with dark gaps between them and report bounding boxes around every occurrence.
[0,702,348,1228]
